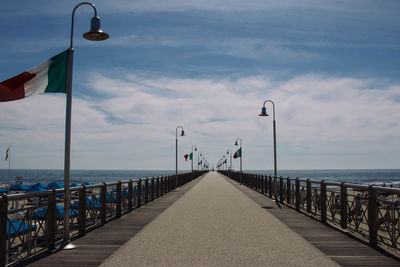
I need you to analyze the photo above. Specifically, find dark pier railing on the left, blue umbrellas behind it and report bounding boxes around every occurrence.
[0,171,205,266]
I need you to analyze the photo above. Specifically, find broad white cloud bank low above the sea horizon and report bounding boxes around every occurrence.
[0,73,400,169]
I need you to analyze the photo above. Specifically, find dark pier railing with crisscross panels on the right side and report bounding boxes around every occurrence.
[220,171,400,256]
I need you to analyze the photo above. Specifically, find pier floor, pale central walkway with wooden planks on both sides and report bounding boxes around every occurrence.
[1,172,400,267]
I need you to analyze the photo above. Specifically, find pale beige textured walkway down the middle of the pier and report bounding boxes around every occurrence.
[101,172,338,267]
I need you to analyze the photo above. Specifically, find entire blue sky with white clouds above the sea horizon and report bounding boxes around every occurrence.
[0,0,400,170]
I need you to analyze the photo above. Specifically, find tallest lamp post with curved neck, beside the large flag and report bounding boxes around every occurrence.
[64,2,109,249]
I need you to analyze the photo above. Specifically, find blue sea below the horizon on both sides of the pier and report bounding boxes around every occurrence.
[0,169,400,187]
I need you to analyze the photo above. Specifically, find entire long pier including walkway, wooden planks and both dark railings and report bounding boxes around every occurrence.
[0,173,400,266]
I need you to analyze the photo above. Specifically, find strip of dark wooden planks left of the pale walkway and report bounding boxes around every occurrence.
[24,176,204,267]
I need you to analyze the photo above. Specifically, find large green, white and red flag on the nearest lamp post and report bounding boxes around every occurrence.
[0,49,68,102]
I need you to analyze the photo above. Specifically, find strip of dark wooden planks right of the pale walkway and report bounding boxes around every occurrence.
[226,178,400,267]
